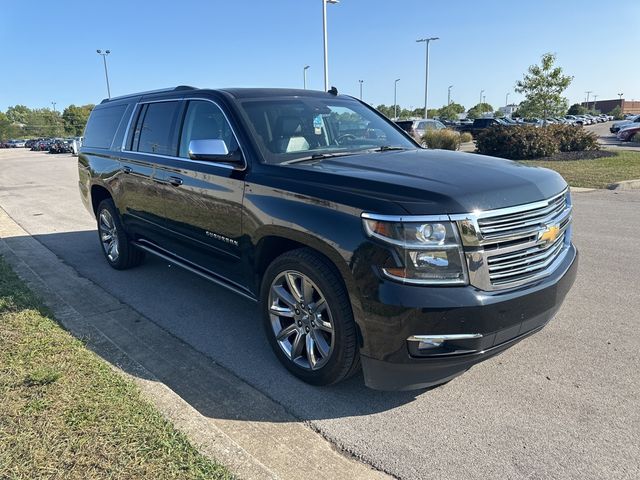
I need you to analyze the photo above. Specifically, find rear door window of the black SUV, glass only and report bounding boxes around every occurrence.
[134,102,180,156]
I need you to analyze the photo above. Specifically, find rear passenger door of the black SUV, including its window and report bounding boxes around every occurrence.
[118,100,183,243]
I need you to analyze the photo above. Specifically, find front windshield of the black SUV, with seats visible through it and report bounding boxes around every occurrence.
[241,96,417,163]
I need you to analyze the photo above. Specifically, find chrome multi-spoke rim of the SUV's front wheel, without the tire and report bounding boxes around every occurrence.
[269,270,335,370]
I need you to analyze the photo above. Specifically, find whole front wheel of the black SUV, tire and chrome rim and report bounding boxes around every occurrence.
[260,248,360,385]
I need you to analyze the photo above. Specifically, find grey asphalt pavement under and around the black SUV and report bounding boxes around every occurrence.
[0,149,640,479]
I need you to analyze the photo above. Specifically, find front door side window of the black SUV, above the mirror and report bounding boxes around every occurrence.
[179,100,238,158]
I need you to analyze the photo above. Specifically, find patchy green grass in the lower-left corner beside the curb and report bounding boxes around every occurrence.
[0,257,232,479]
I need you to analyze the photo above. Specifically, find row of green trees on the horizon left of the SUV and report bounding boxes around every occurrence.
[0,104,95,141]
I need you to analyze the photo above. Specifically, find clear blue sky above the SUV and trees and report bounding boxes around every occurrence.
[0,0,640,110]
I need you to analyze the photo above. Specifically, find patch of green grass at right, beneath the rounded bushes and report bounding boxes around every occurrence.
[522,151,640,188]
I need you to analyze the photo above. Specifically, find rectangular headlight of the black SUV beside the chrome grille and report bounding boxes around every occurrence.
[362,213,467,285]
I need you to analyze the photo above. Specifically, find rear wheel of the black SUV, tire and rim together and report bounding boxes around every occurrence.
[96,198,144,270]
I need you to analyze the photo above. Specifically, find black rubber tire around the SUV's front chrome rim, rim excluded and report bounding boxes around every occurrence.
[260,250,357,385]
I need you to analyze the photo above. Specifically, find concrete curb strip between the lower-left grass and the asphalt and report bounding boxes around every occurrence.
[0,208,391,480]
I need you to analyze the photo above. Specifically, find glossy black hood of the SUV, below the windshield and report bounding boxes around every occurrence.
[292,149,567,215]
